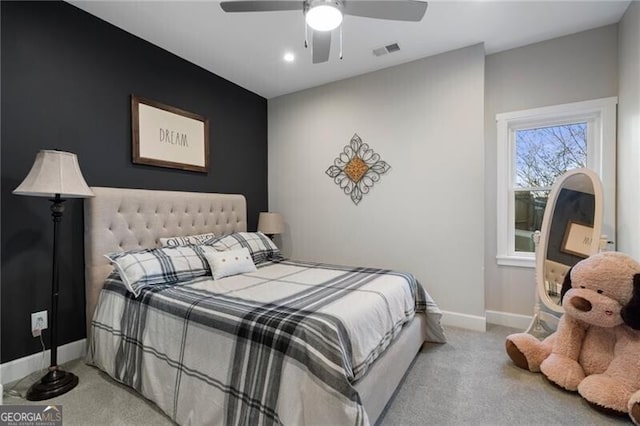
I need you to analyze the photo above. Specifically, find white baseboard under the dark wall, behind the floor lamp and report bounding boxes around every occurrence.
[0,339,87,385]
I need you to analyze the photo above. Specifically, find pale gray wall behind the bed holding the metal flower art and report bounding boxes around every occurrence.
[268,45,485,326]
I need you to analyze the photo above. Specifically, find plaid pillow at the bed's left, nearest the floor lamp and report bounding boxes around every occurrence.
[105,246,215,297]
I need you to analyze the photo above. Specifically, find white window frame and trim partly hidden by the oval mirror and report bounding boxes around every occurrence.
[496,97,618,268]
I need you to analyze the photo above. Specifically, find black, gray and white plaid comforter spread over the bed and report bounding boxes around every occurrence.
[87,261,444,425]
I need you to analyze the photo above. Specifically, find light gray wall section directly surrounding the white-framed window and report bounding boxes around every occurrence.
[484,23,620,315]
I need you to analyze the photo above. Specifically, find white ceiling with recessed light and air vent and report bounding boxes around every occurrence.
[70,0,630,98]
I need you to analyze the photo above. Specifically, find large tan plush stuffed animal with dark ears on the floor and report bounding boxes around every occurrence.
[506,252,640,426]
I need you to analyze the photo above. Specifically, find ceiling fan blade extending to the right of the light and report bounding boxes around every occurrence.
[344,0,428,22]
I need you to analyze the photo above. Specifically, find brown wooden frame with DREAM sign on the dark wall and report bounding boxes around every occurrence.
[131,95,209,173]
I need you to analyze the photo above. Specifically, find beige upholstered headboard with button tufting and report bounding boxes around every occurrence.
[84,187,247,337]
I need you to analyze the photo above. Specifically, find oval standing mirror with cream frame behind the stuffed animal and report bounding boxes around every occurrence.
[534,168,603,328]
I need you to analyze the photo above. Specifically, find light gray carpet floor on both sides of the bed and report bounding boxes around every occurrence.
[4,325,632,426]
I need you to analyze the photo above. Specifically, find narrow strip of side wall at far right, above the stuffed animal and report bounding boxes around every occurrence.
[617,1,640,260]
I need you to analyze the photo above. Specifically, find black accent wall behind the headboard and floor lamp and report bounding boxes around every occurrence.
[0,2,267,363]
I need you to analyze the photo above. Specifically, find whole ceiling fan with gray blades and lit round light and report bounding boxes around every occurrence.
[220,0,427,64]
